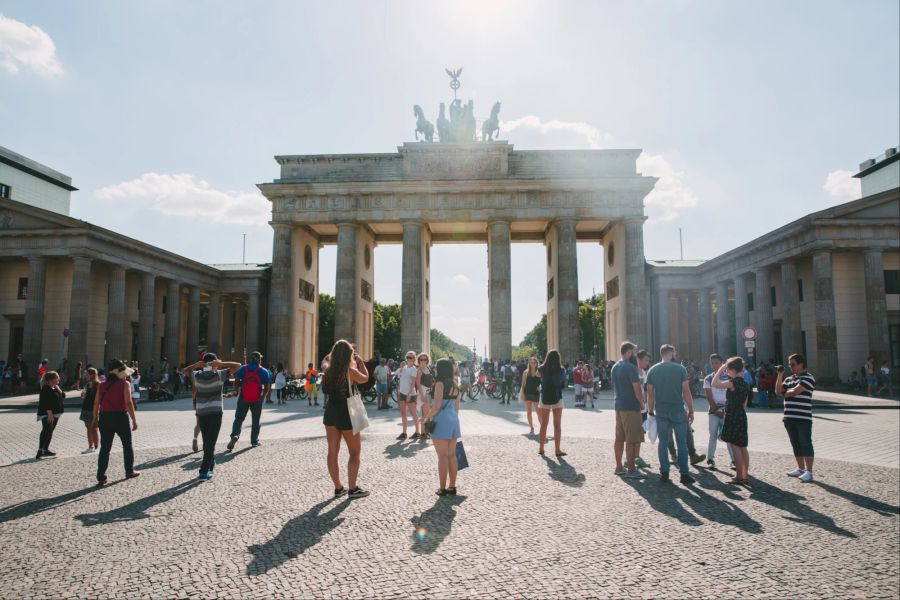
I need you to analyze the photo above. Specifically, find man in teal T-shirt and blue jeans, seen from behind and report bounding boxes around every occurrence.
[647,344,694,485]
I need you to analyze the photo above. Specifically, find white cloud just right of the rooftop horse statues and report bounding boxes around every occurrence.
[500,115,613,150]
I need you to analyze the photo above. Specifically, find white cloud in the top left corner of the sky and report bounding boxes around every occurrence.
[0,14,63,76]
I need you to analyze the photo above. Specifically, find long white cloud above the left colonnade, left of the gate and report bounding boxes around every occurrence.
[96,173,272,225]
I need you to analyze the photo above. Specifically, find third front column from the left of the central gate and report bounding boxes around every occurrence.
[400,221,431,352]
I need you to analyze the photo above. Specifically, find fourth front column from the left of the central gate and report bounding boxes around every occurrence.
[488,221,510,360]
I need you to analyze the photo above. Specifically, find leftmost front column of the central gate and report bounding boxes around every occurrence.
[266,223,292,363]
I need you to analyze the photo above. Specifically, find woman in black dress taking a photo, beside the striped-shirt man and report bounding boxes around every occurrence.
[712,356,750,485]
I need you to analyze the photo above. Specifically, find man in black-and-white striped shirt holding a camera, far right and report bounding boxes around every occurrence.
[775,354,816,483]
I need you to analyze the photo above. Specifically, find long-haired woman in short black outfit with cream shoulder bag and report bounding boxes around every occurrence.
[322,340,369,498]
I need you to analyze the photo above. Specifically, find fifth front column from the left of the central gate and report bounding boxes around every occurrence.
[544,220,580,363]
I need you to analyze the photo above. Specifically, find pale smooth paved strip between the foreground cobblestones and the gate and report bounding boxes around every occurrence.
[0,391,900,468]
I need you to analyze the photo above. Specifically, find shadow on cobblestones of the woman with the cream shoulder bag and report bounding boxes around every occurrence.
[247,497,351,577]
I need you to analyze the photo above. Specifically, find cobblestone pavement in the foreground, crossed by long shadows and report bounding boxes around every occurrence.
[0,432,900,598]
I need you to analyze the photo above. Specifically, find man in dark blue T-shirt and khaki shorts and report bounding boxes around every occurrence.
[612,341,644,478]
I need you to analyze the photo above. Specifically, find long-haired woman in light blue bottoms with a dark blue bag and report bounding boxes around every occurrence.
[425,358,460,496]
